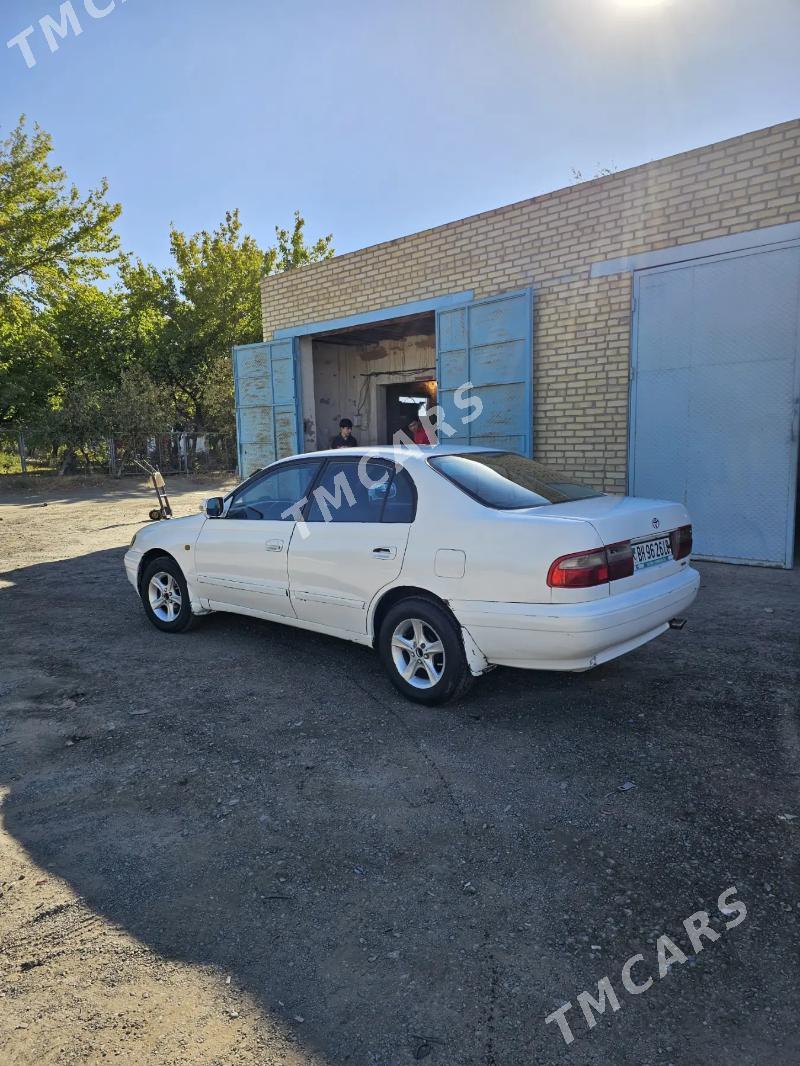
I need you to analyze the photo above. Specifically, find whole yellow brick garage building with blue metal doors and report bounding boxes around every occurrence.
[235,119,800,565]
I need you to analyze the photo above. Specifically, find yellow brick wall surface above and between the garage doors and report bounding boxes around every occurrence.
[261,119,800,491]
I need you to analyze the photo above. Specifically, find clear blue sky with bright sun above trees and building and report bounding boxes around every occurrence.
[0,0,800,264]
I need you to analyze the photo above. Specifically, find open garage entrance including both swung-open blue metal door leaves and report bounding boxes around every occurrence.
[234,288,533,477]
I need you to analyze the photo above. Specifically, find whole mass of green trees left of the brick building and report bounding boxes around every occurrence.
[0,117,334,457]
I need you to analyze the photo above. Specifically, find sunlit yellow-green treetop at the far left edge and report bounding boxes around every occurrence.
[0,116,121,313]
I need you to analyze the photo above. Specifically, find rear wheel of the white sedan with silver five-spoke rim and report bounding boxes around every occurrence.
[378,597,475,706]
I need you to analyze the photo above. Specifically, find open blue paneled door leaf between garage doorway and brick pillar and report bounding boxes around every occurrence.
[436,289,533,455]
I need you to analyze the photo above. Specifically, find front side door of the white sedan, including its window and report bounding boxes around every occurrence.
[195,459,322,617]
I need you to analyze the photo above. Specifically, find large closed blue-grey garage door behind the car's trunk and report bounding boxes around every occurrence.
[630,245,800,566]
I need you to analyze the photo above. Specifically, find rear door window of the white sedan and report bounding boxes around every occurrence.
[306,459,393,522]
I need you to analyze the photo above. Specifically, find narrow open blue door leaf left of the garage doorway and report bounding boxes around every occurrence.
[234,339,301,478]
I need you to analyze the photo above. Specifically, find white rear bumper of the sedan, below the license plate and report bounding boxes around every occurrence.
[450,566,700,671]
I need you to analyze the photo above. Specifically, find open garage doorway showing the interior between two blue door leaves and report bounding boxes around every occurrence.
[301,311,436,451]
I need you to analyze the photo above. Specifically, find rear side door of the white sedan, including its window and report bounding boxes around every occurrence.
[289,457,415,633]
